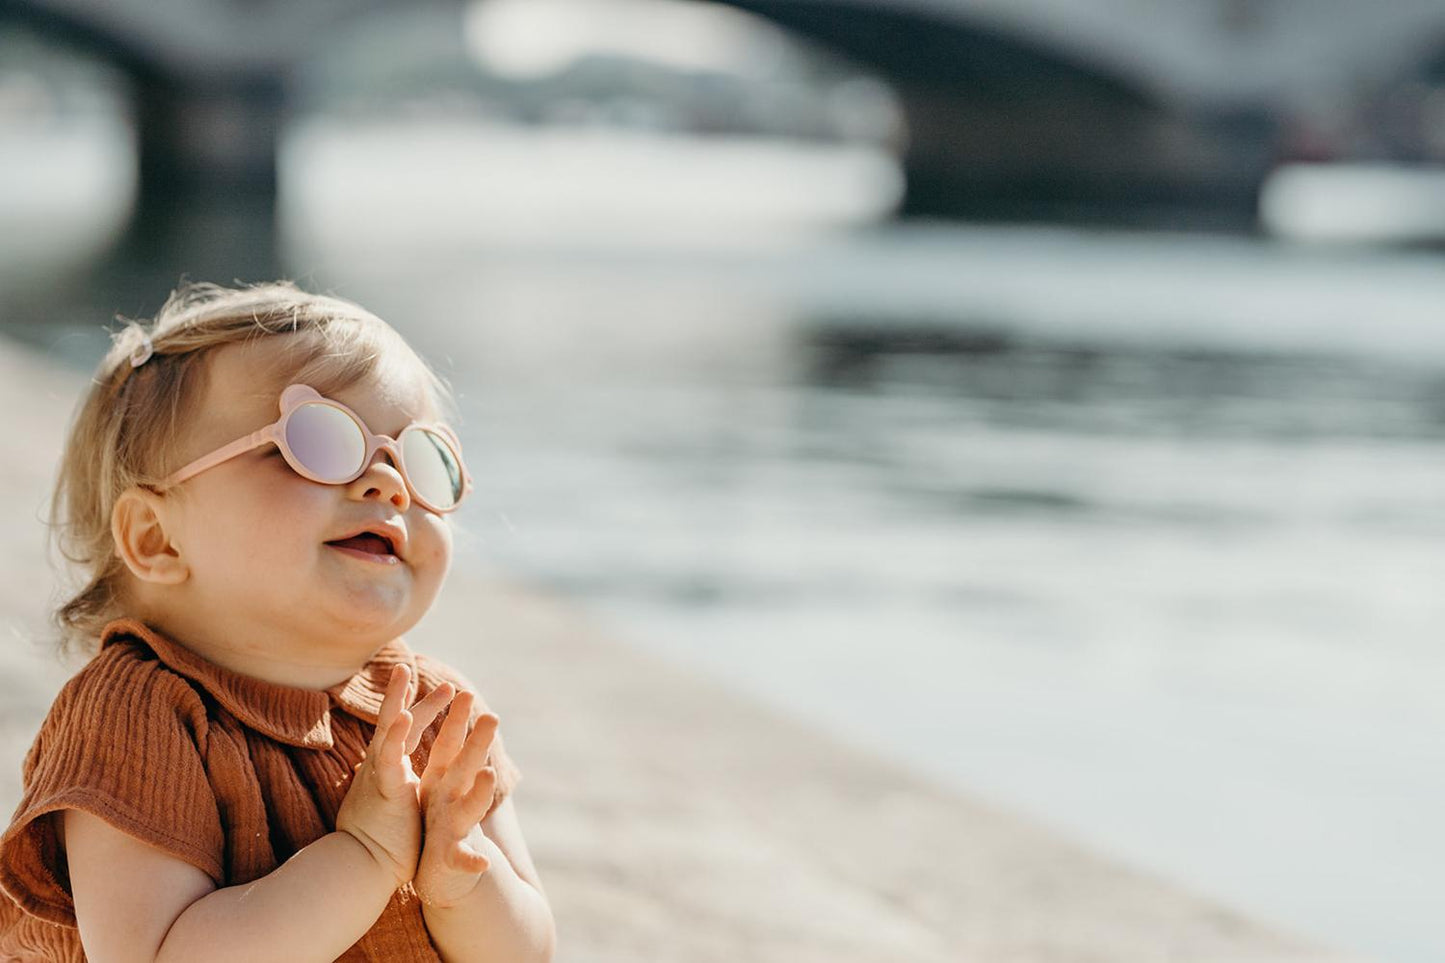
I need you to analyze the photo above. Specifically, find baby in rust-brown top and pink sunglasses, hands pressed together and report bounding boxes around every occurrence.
[0,283,555,963]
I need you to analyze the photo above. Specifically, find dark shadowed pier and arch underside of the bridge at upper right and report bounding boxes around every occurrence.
[728,0,1272,230]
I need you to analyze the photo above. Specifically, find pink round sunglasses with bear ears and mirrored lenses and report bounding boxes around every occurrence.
[162,385,473,513]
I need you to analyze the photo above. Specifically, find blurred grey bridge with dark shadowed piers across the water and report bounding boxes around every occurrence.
[8,0,1445,297]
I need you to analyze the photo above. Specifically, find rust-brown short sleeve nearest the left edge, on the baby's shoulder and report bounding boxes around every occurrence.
[0,645,224,925]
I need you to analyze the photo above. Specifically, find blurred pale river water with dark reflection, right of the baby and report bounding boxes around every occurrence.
[2,122,1445,963]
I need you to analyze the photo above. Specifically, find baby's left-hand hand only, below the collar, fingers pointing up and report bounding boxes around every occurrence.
[337,665,452,886]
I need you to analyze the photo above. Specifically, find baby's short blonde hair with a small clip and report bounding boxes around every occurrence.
[49,281,457,649]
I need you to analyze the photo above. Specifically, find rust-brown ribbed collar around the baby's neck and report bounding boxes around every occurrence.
[100,617,416,749]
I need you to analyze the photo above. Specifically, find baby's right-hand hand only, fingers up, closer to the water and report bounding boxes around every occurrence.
[412,690,504,907]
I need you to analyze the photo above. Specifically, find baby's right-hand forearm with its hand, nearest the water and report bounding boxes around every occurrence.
[412,690,556,963]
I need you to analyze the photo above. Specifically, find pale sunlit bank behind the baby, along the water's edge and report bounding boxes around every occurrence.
[0,335,1347,963]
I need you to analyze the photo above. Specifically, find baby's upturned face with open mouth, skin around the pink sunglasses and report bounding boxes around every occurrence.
[158,335,452,670]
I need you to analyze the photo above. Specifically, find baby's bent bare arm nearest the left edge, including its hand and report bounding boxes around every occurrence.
[64,667,451,963]
